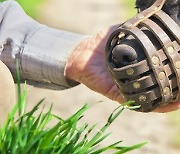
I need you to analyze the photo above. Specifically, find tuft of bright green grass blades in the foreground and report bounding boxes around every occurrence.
[0,61,146,154]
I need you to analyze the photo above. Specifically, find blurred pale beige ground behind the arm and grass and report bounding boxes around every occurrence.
[24,0,180,154]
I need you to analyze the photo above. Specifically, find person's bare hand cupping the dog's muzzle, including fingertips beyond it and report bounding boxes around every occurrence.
[65,26,180,112]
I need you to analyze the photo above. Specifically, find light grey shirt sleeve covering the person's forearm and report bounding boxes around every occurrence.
[0,1,86,89]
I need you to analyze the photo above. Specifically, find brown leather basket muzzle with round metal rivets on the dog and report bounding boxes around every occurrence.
[106,0,180,112]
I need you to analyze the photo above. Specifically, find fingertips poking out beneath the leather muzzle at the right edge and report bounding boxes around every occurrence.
[154,102,180,113]
